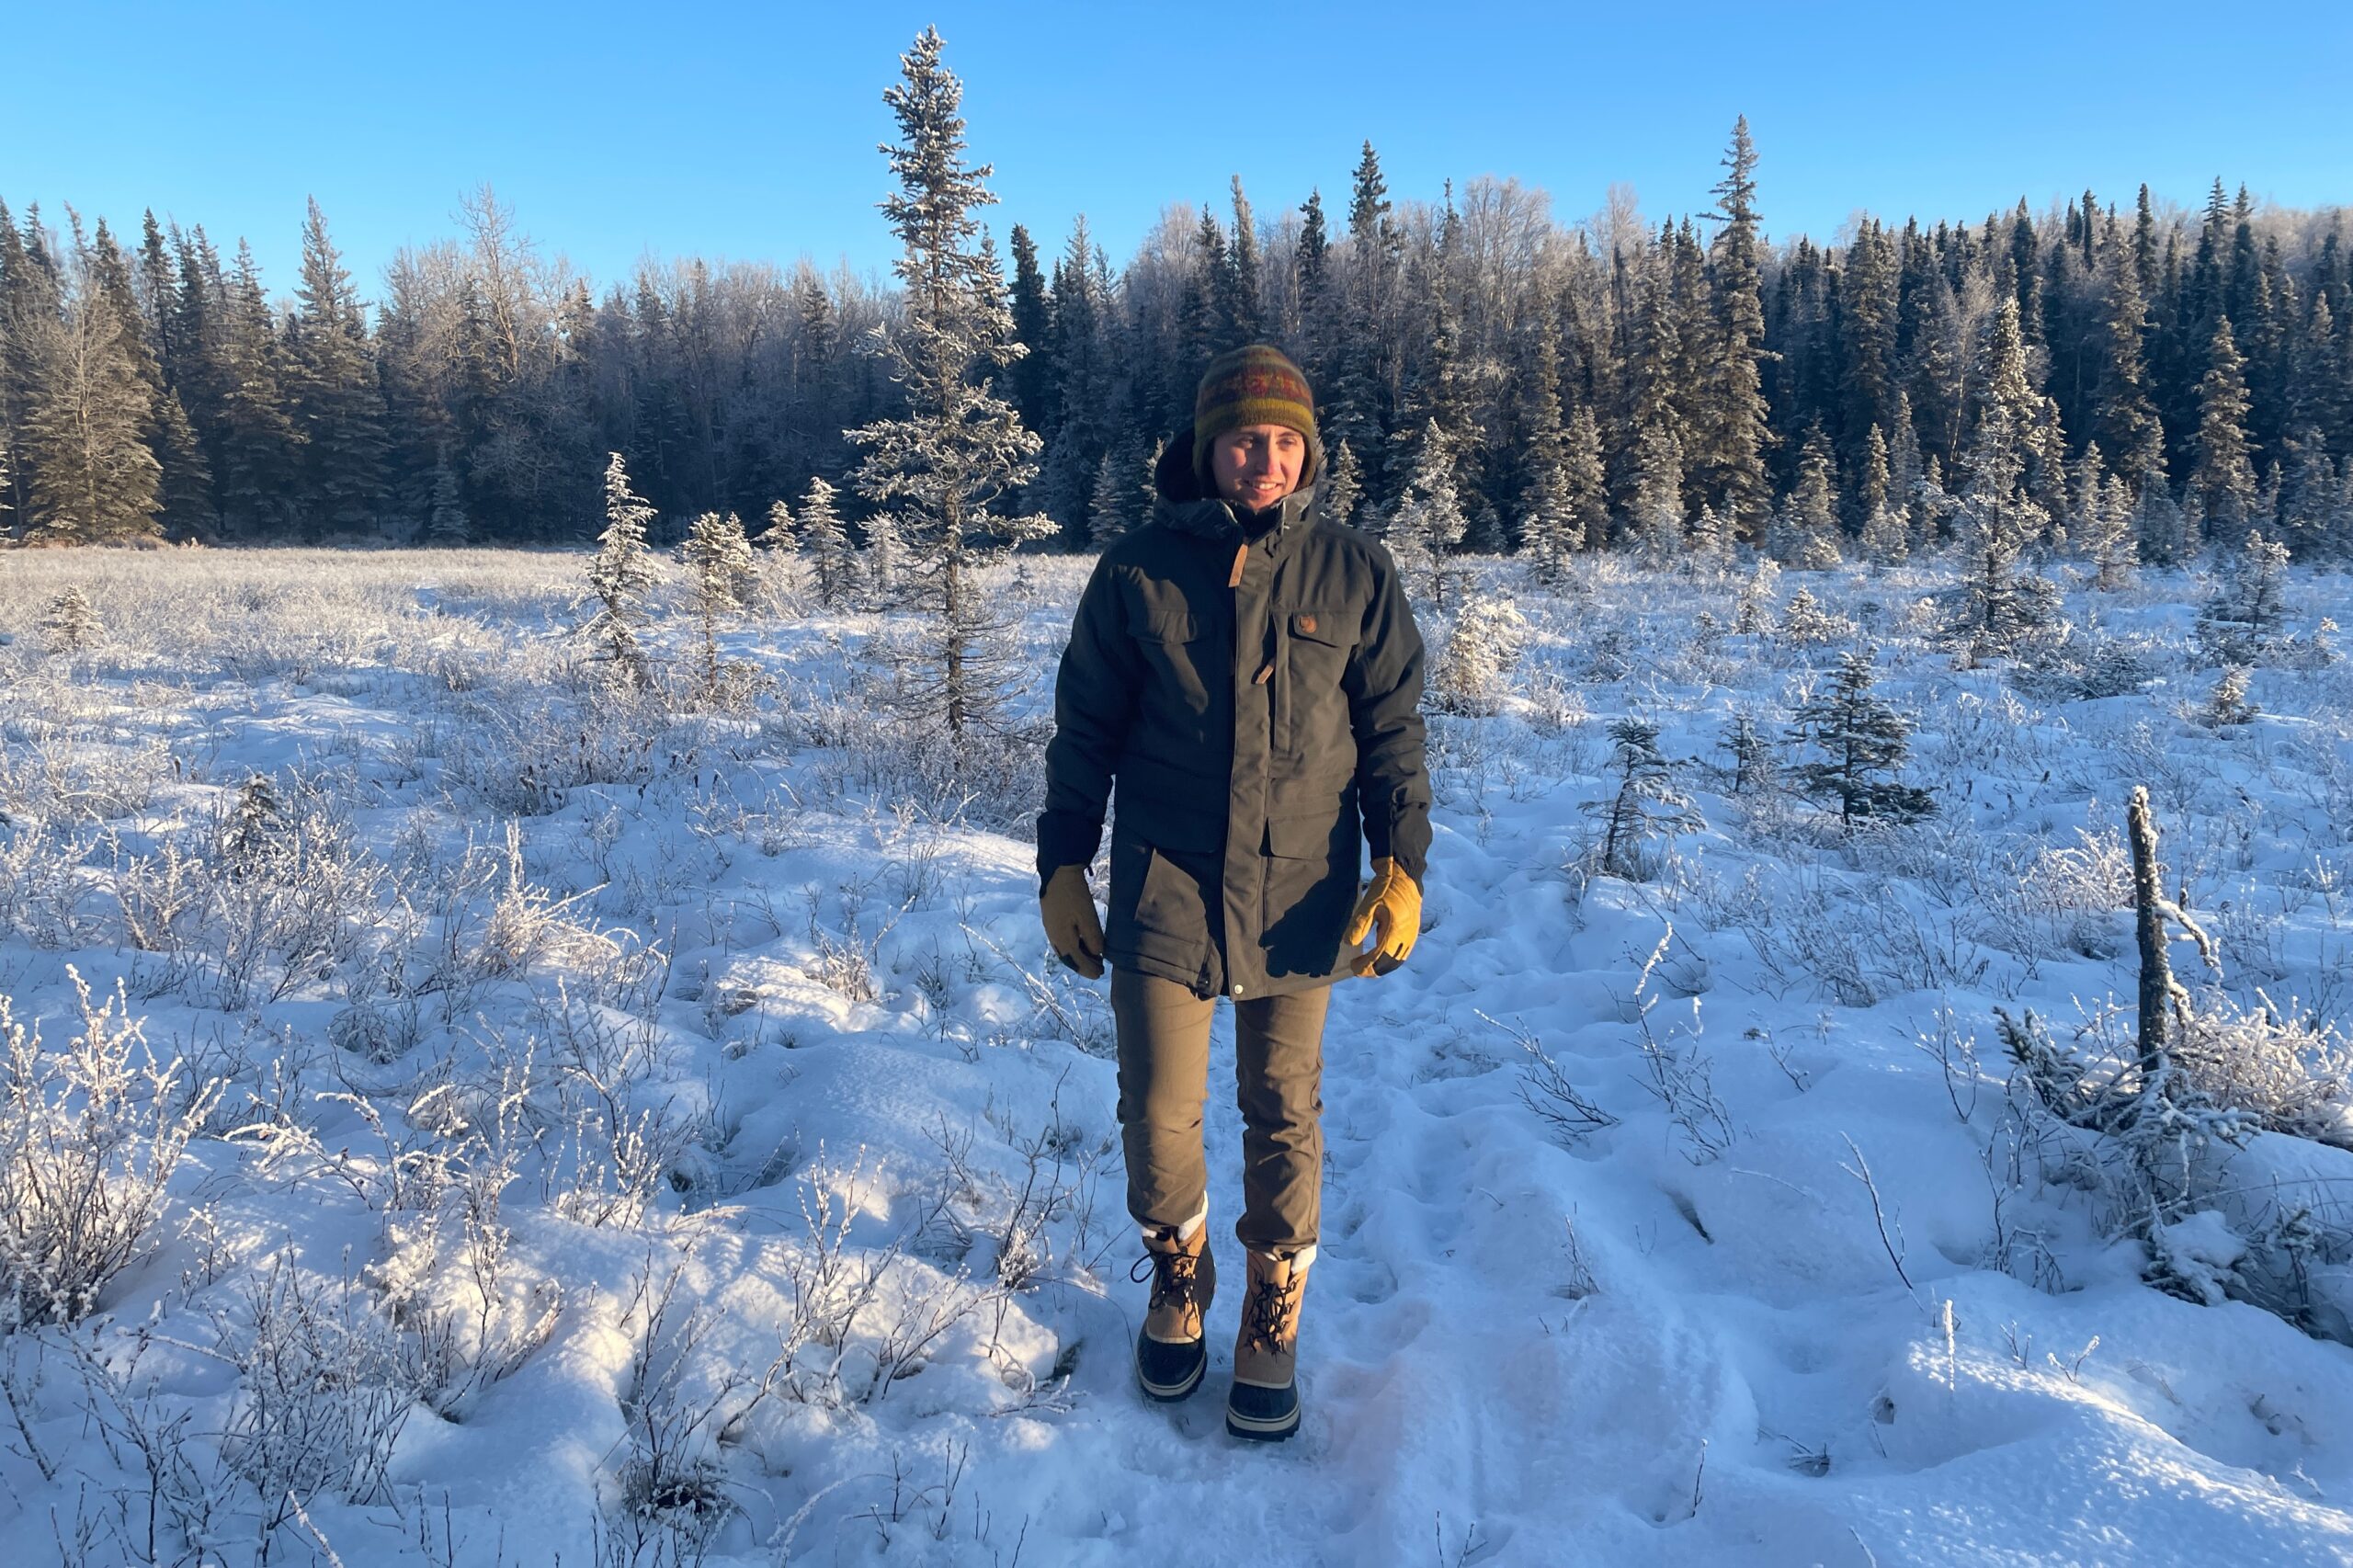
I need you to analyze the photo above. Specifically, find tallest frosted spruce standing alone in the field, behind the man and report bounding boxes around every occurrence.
[849,28,1054,739]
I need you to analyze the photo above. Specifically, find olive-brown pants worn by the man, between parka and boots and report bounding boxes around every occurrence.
[1110,965,1332,1253]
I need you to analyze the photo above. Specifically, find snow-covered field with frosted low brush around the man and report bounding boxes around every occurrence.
[0,551,2353,1568]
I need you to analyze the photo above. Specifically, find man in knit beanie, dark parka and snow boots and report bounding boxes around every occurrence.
[1038,344,1430,1438]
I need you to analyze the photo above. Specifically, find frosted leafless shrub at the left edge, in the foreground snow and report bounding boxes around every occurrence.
[0,965,219,1328]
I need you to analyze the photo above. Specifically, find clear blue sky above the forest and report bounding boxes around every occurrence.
[0,0,2353,292]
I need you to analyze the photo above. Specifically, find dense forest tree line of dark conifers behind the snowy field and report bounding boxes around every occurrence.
[0,108,2353,565]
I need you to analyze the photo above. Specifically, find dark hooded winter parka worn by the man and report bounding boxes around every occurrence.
[1038,431,1430,998]
